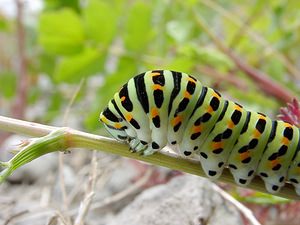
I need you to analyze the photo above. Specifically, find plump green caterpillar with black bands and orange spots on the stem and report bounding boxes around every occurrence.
[100,70,300,195]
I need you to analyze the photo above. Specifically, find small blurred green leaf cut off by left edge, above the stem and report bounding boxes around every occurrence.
[0,71,17,99]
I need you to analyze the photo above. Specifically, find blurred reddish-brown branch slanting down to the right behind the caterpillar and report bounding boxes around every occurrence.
[192,10,296,102]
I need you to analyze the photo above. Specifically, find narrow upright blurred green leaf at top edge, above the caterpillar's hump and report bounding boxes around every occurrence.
[124,1,153,52]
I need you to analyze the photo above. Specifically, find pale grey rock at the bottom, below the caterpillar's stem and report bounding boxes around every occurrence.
[108,175,243,225]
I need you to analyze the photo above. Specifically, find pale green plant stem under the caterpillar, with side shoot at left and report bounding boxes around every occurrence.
[0,116,300,200]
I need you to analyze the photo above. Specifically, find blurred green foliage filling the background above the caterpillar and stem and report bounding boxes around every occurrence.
[0,0,300,206]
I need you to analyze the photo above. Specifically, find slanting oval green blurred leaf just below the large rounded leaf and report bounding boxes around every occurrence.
[54,48,104,83]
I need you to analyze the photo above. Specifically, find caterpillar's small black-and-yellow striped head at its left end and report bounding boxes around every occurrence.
[99,107,128,142]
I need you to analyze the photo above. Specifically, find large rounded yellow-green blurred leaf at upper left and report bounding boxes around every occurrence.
[38,8,84,55]
